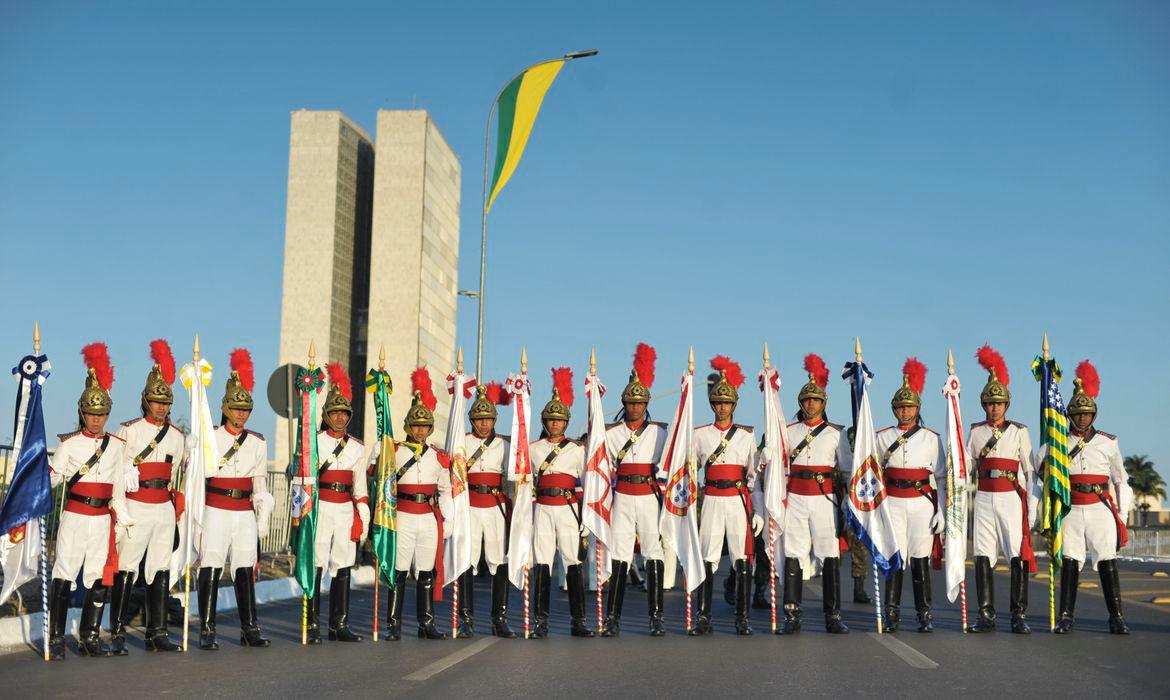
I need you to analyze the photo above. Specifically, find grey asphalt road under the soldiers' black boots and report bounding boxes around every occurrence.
[0,562,1170,698]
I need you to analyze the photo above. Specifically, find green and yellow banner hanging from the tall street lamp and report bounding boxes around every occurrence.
[487,59,565,211]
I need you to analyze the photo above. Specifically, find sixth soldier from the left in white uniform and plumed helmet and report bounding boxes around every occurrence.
[457,382,516,639]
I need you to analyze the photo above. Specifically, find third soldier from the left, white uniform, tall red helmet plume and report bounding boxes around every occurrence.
[199,349,274,651]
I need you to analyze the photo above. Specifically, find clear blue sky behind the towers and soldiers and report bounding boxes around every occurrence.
[0,1,1170,489]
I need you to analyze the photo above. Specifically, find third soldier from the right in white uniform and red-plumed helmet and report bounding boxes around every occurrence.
[878,357,947,632]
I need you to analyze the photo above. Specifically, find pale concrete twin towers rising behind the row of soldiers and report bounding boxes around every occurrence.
[273,110,461,465]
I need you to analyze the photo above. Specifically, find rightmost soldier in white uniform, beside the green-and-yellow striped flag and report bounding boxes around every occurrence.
[1055,359,1134,634]
